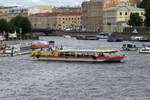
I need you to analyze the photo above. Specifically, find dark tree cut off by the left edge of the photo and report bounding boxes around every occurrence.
[0,19,9,33]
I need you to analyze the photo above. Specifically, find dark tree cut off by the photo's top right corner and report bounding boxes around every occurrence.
[139,0,150,26]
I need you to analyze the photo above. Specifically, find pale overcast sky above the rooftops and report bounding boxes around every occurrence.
[0,0,88,7]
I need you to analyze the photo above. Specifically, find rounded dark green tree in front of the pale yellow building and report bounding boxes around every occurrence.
[128,13,143,27]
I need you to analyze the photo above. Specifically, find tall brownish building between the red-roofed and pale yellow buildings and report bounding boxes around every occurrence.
[81,0,103,32]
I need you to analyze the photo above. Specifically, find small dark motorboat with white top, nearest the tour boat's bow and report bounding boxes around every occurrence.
[122,43,138,51]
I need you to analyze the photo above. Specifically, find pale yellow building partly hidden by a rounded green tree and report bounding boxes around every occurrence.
[103,3,145,32]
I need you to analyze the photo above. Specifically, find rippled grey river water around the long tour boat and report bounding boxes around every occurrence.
[0,37,150,100]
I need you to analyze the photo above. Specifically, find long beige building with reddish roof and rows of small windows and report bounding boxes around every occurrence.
[29,12,81,30]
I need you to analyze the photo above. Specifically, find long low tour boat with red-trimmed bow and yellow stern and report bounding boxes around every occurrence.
[31,48,126,62]
